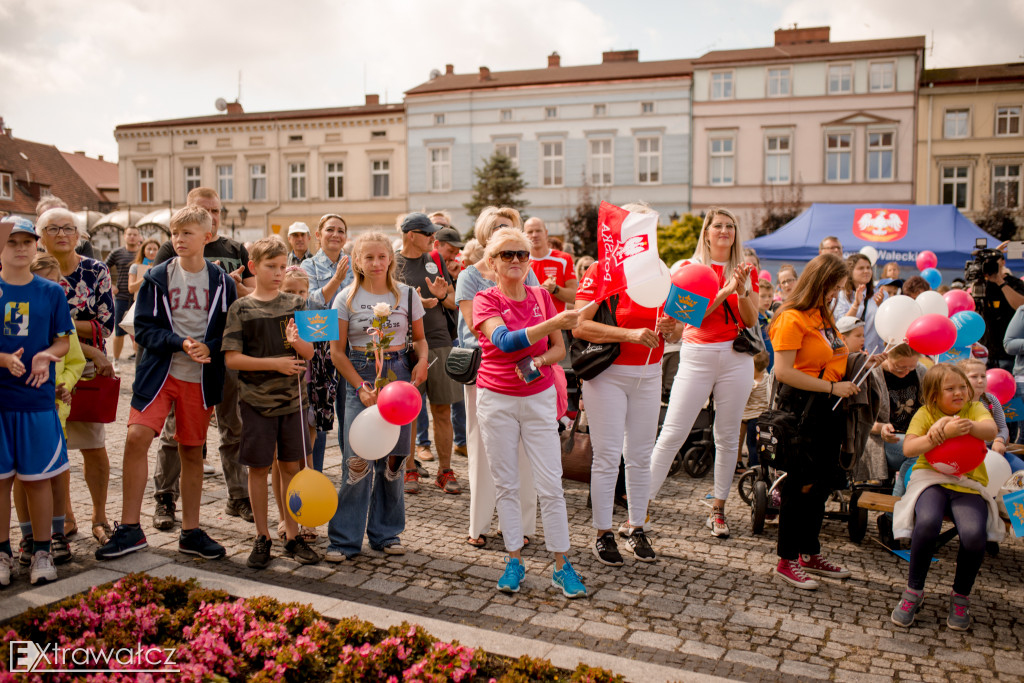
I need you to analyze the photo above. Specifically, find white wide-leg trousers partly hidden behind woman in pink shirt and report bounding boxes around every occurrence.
[464,384,537,539]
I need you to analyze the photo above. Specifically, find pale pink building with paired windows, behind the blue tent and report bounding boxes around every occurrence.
[692,27,925,237]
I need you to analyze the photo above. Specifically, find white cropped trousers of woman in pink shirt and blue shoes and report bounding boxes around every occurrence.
[477,386,569,553]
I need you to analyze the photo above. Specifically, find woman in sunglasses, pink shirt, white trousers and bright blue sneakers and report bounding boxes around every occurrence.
[473,227,587,598]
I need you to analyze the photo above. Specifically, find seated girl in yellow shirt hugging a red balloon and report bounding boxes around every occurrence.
[891,362,1006,631]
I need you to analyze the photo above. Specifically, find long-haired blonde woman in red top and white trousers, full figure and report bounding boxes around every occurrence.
[650,207,758,538]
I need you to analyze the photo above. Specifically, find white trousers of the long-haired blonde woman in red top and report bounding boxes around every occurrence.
[650,342,754,501]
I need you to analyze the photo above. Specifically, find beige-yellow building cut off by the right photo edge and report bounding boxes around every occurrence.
[915,63,1024,219]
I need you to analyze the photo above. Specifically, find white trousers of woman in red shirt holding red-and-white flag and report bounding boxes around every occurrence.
[583,365,662,530]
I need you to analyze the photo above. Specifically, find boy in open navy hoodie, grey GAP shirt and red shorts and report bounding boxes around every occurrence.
[96,206,237,560]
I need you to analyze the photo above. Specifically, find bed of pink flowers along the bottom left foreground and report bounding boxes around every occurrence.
[0,574,623,683]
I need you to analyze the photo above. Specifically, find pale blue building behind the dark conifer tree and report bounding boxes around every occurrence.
[406,50,691,232]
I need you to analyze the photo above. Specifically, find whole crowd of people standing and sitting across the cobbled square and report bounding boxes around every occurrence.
[0,192,1024,630]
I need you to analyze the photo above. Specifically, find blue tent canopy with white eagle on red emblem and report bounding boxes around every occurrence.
[743,204,998,276]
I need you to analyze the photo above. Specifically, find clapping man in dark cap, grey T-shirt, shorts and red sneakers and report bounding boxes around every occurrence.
[395,213,462,494]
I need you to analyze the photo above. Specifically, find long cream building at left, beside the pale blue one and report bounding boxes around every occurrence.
[114,95,408,240]
